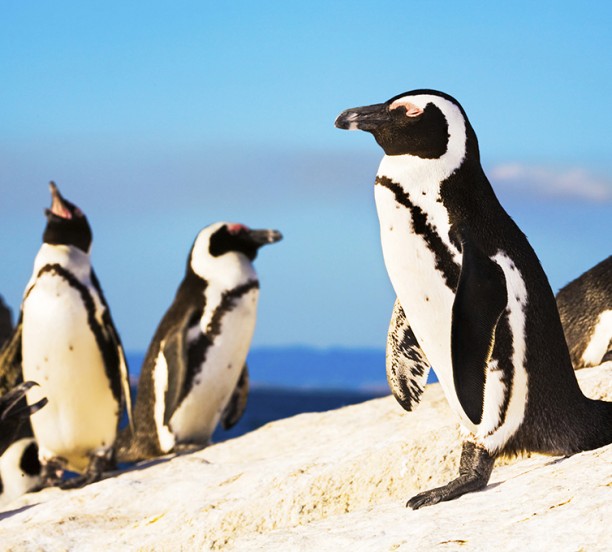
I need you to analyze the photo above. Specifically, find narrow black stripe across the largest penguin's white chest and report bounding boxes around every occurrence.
[376,176,460,291]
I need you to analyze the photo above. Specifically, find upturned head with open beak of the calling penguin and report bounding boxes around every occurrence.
[43,182,92,253]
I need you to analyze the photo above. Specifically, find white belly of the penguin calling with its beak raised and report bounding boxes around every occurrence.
[22,274,119,471]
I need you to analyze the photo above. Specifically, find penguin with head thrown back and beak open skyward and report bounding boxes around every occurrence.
[13,182,131,489]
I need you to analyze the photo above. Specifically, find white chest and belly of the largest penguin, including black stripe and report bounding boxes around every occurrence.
[375,185,472,425]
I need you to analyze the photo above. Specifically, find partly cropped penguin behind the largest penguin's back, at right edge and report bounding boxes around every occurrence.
[557,255,612,370]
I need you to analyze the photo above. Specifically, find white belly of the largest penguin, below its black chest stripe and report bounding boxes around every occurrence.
[375,186,475,431]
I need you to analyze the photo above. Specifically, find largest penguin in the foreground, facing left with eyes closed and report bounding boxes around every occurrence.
[335,90,612,509]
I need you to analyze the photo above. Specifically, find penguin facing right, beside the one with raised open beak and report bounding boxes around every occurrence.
[119,222,282,461]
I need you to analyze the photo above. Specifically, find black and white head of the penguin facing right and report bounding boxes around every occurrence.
[189,222,283,279]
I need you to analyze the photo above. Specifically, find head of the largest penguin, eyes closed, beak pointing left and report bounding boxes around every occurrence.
[335,90,478,159]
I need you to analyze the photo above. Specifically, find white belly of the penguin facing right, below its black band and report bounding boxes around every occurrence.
[170,289,258,444]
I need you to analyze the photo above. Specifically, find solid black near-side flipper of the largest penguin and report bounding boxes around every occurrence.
[451,229,508,424]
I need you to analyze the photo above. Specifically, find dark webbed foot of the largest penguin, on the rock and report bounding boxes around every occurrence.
[406,441,495,510]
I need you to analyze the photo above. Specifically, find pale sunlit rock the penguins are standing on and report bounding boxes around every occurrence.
[0,363,612,552]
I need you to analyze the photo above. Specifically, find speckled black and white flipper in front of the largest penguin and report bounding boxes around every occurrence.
[386,299,429,411]
